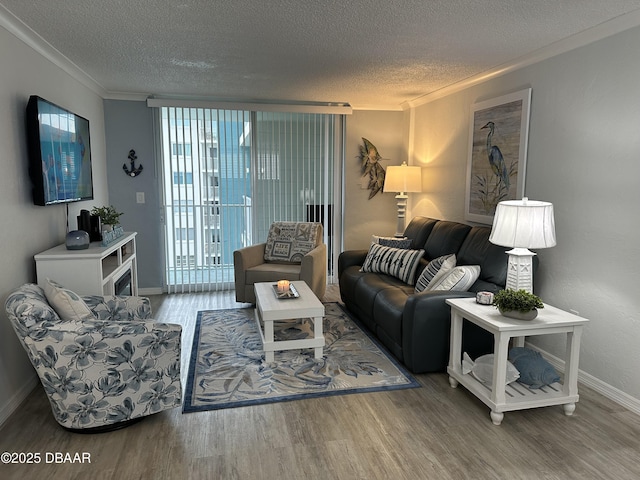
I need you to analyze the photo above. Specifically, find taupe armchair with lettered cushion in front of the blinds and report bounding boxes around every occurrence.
[233,222,327,303]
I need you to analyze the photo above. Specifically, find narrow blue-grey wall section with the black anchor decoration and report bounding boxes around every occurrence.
[104,100,164,294]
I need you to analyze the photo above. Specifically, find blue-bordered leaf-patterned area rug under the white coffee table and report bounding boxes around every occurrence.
[182,303,420,412]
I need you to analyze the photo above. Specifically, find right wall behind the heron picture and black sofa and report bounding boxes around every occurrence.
[412,24,640,409]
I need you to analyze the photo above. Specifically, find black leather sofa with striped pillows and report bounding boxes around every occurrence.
[338,217,507,373]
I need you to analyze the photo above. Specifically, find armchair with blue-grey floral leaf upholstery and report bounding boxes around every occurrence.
[5,284,182,432]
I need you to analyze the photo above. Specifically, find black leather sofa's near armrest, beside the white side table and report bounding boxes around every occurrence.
[402,291,475,373]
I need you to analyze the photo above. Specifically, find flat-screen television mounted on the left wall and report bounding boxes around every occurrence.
[27,95,93,205]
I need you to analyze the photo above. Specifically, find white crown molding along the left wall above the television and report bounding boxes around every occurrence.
[0,5,107,98]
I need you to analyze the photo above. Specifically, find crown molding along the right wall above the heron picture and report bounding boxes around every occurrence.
[401,10,640,110]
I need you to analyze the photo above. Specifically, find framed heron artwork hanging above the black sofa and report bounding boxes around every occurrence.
[465,88,531,224]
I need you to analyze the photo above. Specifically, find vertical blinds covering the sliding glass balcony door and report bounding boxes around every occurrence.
[159,107,344,293]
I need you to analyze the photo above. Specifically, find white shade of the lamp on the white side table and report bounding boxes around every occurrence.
[489,197,556,248]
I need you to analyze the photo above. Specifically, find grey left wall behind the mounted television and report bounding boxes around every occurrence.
[0,26,107,423]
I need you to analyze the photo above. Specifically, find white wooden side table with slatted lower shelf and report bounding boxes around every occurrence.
[447,298,588,425]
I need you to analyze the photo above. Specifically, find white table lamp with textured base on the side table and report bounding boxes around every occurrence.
[489,197,556,293]
